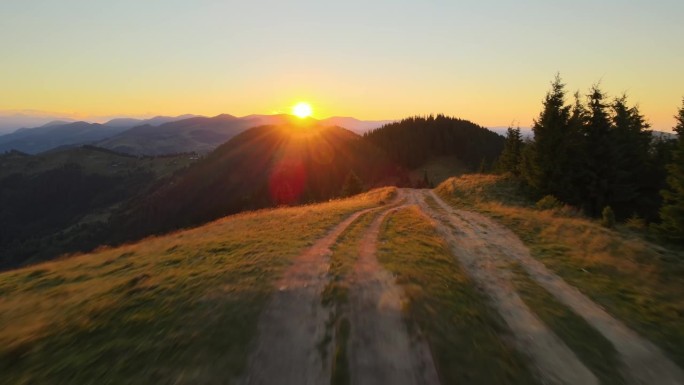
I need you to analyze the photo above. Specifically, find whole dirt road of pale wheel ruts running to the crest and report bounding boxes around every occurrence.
[240,189,684,385]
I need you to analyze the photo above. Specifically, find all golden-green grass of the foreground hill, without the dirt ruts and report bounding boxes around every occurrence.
[0,175,684,384]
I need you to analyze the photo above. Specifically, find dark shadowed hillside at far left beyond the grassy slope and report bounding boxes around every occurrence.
[0,146,198,268]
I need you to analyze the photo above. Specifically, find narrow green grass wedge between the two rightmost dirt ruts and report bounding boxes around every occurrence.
[511,264,625,385]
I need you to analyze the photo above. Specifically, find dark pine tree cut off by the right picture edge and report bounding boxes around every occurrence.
[659,100,684,242]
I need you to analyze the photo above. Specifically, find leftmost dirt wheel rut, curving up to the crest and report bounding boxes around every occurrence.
[238,192,403,385]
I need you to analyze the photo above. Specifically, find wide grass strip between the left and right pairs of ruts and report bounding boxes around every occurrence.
[378,207,536,384]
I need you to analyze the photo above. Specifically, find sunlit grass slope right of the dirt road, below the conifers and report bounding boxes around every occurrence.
[436,175,684,367]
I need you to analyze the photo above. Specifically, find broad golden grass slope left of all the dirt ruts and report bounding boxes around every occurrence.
[0,185,395,384]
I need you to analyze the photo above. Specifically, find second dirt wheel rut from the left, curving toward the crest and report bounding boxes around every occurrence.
[349,205,439,385]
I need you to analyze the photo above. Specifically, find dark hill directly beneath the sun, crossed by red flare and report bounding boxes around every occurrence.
[113,121,392,239]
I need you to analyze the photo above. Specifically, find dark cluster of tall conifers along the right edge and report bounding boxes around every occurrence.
[497,76,684,239]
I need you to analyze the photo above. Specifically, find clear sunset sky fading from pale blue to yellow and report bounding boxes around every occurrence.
[0,0,684,131]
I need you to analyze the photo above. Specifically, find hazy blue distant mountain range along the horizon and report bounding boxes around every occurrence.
[0,114,392,155]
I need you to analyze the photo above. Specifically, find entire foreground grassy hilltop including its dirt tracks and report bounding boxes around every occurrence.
[0,180,684,385]
